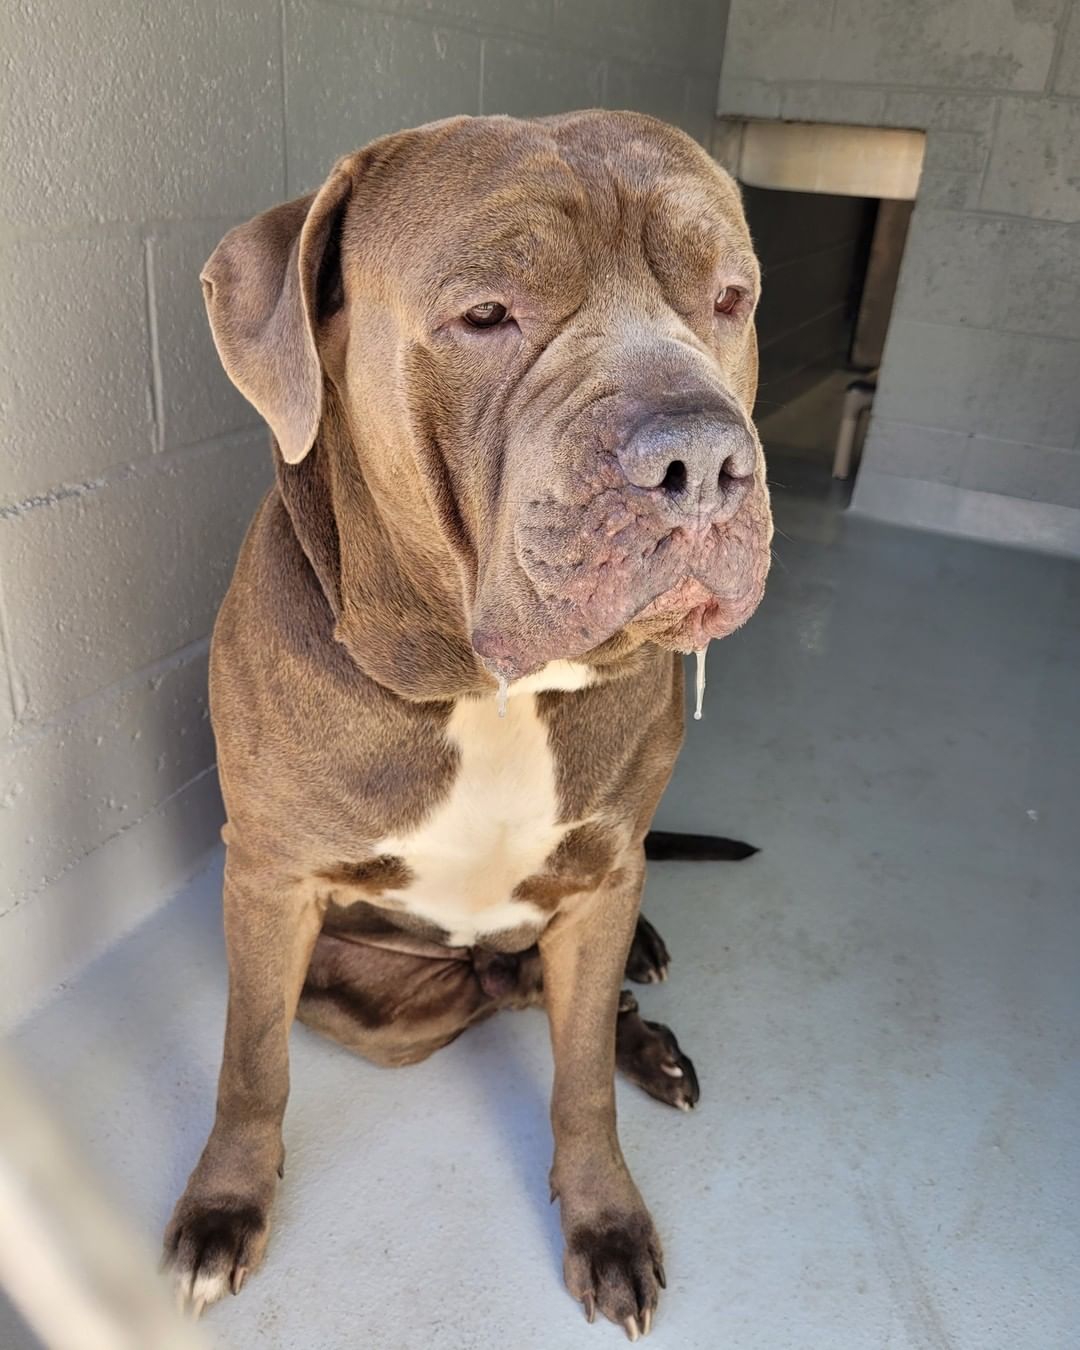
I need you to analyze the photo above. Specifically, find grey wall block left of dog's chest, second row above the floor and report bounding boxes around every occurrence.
[0,647,213,902]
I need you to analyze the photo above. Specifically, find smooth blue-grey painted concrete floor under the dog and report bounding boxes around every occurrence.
[0,456,1080,1350]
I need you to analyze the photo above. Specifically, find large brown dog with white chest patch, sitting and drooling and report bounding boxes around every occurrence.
[166,112,771,1338]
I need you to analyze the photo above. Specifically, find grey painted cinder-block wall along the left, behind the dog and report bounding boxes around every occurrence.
[0,0,726,1023]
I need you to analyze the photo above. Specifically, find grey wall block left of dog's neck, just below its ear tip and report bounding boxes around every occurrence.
[0,432,270,722]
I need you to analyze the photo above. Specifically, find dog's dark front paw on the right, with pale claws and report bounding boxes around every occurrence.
[563,1210,666,1341]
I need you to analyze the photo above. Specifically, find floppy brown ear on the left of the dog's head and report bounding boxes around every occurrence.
[200,157,354,464]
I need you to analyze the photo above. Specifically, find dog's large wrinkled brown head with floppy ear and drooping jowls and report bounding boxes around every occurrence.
[203,112,772,679]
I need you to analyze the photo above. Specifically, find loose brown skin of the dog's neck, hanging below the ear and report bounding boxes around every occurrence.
[274,408,495,702]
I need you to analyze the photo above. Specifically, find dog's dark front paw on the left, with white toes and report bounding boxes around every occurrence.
[162,1195,270,1318]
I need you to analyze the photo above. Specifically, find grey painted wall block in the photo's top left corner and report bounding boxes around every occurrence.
[0,0,284,228]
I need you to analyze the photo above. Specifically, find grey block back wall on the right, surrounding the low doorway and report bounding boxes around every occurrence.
[718,0,1080,554]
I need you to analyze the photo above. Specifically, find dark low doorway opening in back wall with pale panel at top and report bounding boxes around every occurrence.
[714,122,925,495]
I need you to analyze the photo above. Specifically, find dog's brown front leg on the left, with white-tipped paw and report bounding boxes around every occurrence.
[165,846,321,1315]
